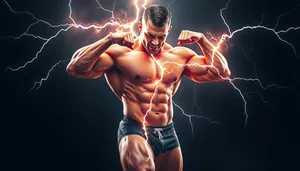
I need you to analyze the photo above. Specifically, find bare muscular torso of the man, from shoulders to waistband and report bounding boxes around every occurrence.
[105,45,186,126]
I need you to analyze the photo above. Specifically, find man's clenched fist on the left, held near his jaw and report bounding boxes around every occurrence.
[110,32,134,49]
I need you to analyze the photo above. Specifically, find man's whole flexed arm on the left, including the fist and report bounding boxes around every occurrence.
[67,32,133,78]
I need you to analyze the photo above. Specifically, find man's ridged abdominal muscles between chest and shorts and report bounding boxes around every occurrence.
[122,83,173,126]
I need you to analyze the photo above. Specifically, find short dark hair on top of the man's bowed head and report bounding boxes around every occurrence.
[143,5,172,27]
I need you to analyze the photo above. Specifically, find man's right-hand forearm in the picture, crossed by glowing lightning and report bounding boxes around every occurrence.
[197,36,230,77]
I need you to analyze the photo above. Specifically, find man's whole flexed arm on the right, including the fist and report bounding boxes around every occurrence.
[178,30,230,82]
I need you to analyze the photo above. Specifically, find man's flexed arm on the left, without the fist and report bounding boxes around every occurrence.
[66,35,114,78]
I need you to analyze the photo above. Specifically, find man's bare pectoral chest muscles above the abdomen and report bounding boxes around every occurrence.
[116,53,184,84]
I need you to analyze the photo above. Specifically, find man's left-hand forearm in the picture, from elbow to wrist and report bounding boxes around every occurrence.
[67,36,112,73]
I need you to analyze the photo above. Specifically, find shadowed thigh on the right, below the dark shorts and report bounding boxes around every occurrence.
[154,147,183,171]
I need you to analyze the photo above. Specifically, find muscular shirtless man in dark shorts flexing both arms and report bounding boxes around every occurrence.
[67,5,230,171]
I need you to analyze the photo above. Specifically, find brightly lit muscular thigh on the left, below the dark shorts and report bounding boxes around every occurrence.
[119,134,155,171]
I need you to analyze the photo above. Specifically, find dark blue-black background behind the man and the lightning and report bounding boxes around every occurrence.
[0,0,300,171]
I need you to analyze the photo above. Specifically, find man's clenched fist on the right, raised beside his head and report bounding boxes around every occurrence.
[177,30,204,46]
